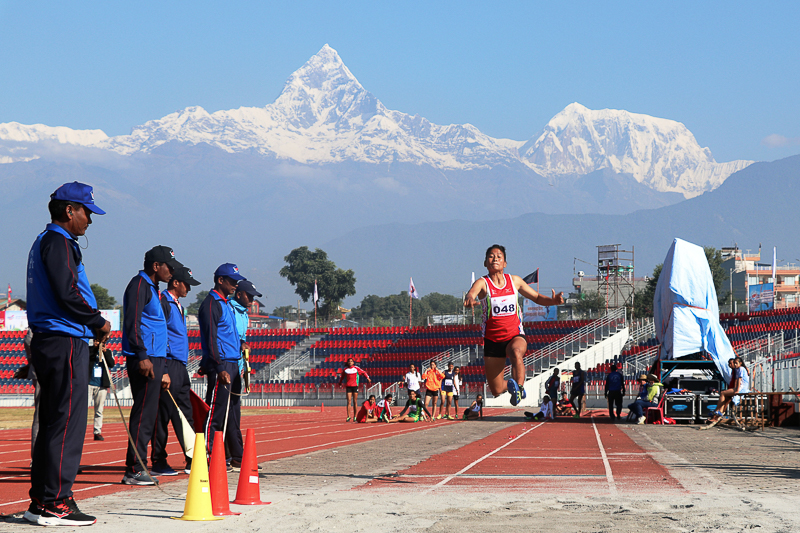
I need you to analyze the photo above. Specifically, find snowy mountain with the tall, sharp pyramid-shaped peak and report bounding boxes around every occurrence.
[103,45,521,170]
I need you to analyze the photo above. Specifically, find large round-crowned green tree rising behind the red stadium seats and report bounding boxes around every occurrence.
[279,246,356,318]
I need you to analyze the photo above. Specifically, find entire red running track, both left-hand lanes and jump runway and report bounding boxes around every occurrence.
[0,408,683,514]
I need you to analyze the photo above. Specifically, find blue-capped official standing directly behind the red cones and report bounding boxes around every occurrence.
[197,263,244,468]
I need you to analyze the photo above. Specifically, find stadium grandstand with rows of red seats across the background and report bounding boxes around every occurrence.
[0,308,800,405]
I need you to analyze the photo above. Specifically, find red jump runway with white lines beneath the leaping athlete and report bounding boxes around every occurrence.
[362,418,683,494]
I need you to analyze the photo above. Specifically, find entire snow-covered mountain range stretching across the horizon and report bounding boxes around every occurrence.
[0,44,751,197]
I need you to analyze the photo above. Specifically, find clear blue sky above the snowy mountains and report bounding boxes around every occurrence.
[0,0,800,161]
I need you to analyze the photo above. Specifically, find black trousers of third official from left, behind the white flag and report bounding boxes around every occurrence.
[150,358,194,465]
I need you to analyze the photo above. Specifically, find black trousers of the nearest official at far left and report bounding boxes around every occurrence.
[29,333,89,504]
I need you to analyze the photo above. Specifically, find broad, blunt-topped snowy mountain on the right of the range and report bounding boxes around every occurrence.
[520,103,752,197]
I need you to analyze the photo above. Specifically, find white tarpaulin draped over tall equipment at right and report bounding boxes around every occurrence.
[653,239,736,382]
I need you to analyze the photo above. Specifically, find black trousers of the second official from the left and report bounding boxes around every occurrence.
[125,357,164,472]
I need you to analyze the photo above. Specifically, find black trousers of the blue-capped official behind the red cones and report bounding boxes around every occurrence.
[205,361,244,461]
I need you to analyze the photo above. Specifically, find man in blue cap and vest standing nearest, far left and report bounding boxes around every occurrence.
[24,181,111,526]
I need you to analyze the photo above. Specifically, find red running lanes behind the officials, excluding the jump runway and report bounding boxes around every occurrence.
[0,407,509,514]
